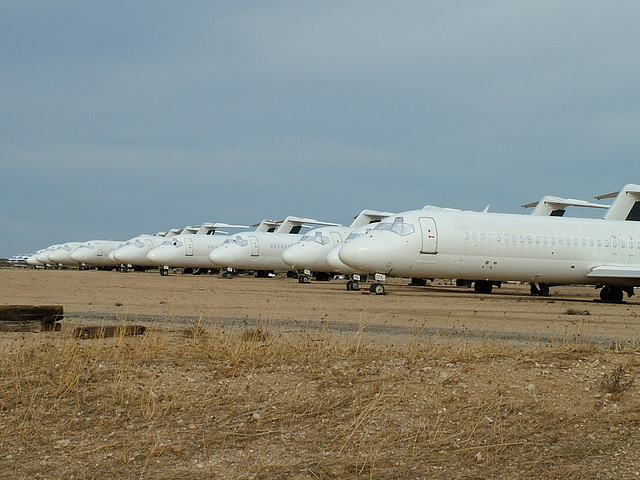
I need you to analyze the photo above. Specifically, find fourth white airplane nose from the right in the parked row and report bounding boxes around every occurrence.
[209,217,339,278]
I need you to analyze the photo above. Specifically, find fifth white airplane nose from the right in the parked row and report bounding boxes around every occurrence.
[147,223,251,276]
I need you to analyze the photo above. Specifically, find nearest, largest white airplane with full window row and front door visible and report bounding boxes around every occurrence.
[338,185,640,302]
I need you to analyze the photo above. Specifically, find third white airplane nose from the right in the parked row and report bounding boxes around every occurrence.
[282,210,393,288]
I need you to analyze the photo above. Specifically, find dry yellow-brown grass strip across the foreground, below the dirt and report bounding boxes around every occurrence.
[0,322,640,479]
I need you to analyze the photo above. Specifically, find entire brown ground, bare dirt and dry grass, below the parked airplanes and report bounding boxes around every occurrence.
[0,269,640,479]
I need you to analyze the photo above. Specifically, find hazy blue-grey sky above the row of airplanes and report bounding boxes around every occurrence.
[0,0,640,258]
